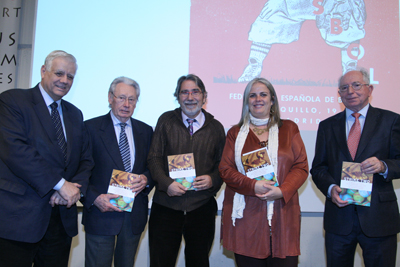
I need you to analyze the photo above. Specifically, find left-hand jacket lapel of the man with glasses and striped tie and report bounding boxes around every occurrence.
[99,113,124,170]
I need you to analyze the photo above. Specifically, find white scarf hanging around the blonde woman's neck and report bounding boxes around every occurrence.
[232,114,279,226]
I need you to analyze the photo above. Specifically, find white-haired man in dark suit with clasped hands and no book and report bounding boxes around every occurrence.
[0,50,93,267]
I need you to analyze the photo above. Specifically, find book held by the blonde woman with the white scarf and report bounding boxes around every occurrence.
[242,147,278,186]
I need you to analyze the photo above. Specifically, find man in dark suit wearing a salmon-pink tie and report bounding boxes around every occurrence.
[311,70,400,267]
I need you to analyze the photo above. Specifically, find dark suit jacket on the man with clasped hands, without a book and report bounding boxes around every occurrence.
[0,85,93,243]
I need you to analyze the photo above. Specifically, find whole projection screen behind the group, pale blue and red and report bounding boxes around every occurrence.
[32,0,400,212]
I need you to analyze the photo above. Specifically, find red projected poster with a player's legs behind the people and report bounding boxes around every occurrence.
[189,0,400,130]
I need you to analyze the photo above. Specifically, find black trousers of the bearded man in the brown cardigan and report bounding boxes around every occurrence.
[149,198,217,267]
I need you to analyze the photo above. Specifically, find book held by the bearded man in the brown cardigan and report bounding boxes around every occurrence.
[168,153,196,190]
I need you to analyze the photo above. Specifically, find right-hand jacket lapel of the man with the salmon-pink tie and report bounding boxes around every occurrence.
[355,106,380,159]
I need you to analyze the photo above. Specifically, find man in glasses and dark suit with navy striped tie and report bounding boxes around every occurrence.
[83,77,153,267]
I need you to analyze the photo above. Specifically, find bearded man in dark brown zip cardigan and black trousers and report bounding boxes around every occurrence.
[148,74,225,267]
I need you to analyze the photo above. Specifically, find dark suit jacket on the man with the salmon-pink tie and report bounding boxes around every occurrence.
[311,106,400,237]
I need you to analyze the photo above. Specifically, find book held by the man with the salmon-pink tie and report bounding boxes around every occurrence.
[339,161,374,207]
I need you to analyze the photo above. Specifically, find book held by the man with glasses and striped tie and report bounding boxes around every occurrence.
[107,169,139,212]
